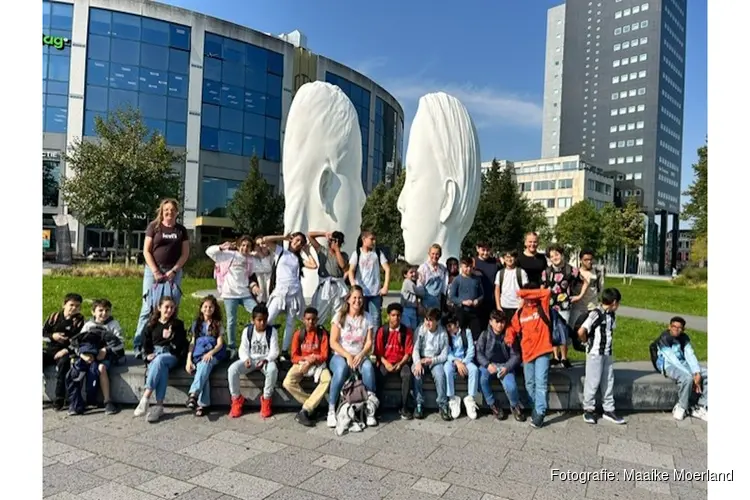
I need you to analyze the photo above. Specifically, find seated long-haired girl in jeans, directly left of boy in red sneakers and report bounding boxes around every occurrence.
[185,295,226,417]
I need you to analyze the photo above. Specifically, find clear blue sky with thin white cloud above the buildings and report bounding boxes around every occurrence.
[167,0,707,201]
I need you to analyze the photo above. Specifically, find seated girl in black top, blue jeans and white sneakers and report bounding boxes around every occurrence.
[133,296,188,422]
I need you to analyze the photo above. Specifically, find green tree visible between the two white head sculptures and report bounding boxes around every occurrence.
[362,171,406,258]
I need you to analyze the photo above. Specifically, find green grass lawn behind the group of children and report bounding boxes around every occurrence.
[40,276,708,361]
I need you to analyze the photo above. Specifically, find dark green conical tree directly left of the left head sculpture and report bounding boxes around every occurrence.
[227,155,284,235]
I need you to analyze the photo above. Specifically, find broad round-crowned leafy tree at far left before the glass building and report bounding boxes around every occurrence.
[60,107,184,256]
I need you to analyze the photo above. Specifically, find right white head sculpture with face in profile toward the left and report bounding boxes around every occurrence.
[398,92,482,264]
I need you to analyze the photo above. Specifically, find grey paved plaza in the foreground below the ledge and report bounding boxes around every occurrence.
[43,408,707,500]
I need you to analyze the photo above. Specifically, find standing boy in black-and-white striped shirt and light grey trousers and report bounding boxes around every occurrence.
[578,288,625,425]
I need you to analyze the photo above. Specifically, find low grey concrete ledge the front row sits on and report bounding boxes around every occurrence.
[43,356,692,411]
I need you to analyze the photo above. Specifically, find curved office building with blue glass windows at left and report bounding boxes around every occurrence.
[42,0,404,253]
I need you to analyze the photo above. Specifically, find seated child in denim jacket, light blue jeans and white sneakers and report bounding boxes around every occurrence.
[442,316,479,420]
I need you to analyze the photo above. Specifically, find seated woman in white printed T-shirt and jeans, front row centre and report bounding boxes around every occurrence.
[327,285,378,427]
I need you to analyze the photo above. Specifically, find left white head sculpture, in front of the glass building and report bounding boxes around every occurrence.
[282,81,365,297]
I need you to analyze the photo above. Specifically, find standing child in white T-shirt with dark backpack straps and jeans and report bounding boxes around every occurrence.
[348,231,391,331]
